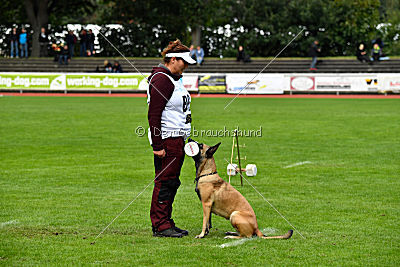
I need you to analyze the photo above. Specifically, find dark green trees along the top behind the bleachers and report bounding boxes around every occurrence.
[0,0,400,56]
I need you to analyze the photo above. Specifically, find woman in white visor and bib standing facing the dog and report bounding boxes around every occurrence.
[147,40,196,237]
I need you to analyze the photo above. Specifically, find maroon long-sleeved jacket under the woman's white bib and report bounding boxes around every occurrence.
[147,64,182,151]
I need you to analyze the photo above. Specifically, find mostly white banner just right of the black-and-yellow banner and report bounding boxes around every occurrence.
[226,74,285,94]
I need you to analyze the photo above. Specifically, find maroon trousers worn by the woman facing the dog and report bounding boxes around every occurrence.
[150,137,185,232]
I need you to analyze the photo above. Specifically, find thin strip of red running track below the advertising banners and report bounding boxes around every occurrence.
[0,92,400,99]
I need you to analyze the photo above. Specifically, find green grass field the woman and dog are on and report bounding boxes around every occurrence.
[0,97,400,266]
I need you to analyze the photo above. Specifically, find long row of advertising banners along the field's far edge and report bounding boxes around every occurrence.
[0,72,400,94]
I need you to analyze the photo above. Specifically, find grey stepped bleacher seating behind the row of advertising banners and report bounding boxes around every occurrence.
[0,57,400,73]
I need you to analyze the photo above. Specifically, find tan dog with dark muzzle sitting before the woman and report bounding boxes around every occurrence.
[189,139,293,239]
